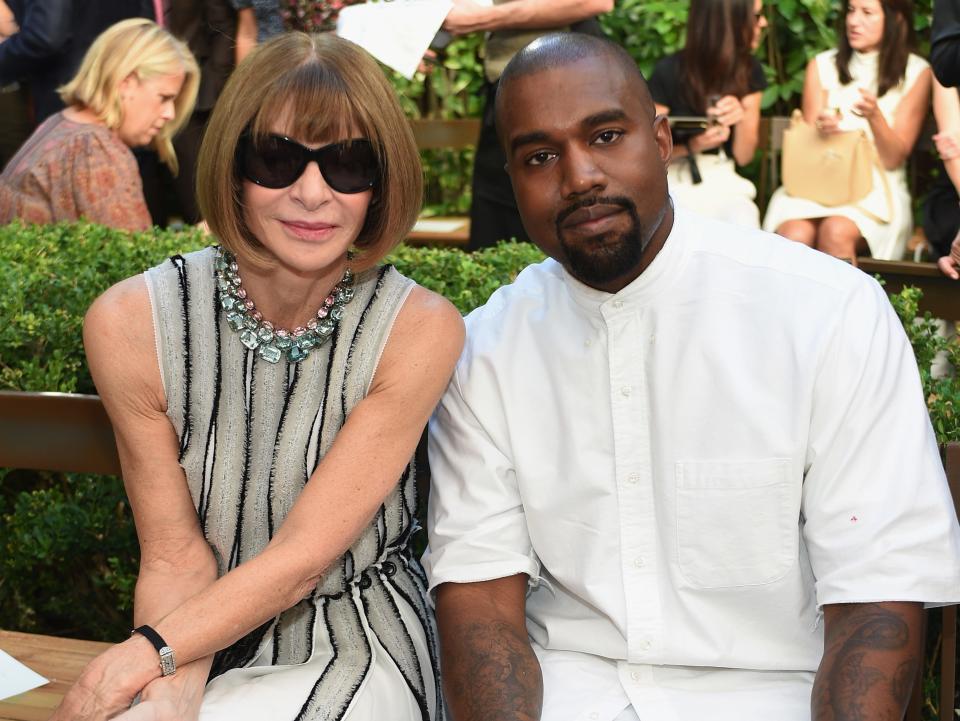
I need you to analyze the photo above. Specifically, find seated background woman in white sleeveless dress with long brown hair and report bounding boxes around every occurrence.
[763,0,931,260]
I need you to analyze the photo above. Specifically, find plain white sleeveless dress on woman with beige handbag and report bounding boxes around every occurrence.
[763,49,930,260]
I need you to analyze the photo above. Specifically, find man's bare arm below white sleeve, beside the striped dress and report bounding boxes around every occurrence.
[437,574,543,721]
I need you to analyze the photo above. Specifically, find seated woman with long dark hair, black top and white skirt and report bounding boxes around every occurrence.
[650,0,767,228]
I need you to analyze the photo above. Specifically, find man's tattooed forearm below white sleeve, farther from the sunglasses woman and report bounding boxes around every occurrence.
[811,602,923,721]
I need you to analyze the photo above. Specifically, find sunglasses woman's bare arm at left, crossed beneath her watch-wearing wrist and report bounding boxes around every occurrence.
[78,276,217,721]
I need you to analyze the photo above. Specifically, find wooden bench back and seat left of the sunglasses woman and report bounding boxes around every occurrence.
[0,391,120,721]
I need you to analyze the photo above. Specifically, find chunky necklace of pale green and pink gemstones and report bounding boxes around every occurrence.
[215,247,354,363]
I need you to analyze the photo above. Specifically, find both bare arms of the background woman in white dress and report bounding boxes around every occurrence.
[803,60,931,170]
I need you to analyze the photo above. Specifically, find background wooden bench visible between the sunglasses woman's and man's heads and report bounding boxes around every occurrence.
[406,118,480,248]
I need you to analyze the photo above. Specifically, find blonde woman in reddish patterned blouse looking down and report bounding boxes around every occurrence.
[0,18,199,230]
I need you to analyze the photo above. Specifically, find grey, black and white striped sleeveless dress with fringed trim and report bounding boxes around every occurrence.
[145,248,443,721]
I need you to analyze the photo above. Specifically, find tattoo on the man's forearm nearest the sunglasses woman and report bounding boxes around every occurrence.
[443,621,543,721]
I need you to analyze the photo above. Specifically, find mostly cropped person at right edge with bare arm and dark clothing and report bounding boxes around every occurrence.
[923,75,960,280]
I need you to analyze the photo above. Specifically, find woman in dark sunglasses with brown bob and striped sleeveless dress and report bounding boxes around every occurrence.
[53,34,463,721]
